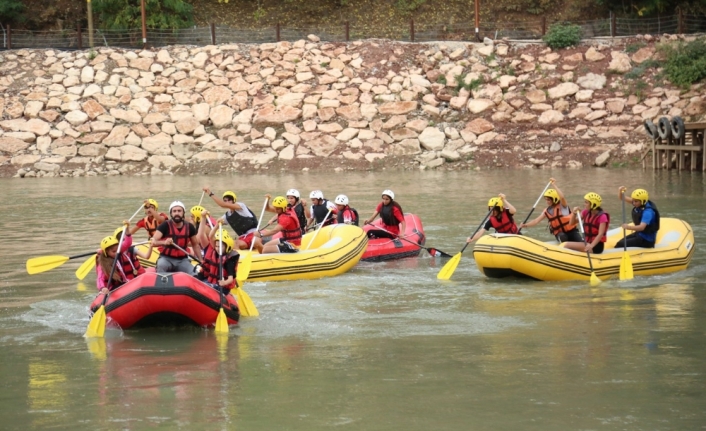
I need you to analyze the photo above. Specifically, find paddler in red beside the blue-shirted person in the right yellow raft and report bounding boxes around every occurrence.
[564,192,610,254]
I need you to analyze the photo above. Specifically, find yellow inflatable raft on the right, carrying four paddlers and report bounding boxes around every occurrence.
[473,218,695,281]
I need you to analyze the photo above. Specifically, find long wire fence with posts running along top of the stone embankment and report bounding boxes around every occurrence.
[0,14,706,50]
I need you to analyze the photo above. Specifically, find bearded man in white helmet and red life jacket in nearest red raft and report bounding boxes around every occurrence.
[152,201,201,274]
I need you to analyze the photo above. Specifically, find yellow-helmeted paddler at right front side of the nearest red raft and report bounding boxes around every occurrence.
[197,224,240,294]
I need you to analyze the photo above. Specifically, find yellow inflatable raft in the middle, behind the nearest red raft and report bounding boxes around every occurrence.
[139,224,368,281]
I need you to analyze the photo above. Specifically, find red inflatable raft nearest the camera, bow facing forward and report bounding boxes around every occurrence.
[91,272,240,329]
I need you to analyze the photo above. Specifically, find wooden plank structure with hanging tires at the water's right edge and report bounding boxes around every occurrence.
[642,117,706,172]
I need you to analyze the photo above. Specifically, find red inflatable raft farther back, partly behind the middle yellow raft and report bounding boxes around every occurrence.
[361,214,426,262]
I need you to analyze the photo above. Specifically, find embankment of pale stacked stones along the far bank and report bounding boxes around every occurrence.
[0,35,706,177]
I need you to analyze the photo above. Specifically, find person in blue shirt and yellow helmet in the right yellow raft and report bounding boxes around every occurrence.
[615,186,659,248]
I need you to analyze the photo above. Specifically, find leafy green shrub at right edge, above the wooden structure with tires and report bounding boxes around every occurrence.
[661,37,706,88]
